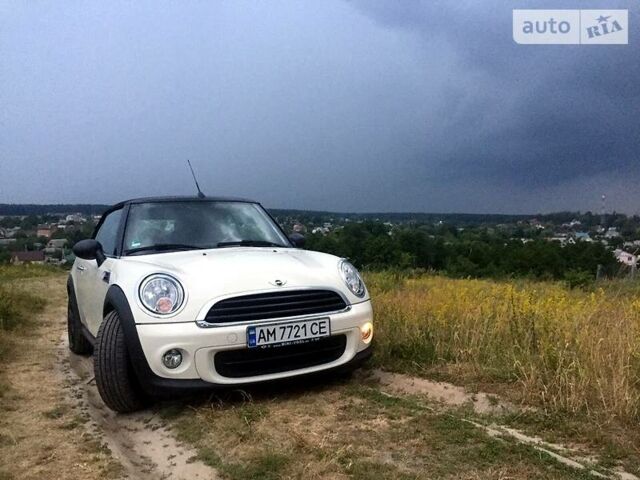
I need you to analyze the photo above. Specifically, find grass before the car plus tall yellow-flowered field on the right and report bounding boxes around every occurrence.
[159,272,640,479]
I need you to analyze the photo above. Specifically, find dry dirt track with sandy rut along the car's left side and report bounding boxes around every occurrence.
[0,276,217,480]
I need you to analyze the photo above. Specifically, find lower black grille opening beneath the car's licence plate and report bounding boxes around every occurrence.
[214,335,347,378]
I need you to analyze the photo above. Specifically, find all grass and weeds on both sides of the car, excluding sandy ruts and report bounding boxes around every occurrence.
[0,267,640,480]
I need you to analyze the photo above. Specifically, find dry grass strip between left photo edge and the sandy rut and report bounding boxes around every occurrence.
[0,266,121,480]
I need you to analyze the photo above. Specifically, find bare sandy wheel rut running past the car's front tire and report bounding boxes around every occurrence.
[57,335,215,480]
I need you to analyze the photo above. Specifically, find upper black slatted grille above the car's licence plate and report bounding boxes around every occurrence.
[205,290,347,323]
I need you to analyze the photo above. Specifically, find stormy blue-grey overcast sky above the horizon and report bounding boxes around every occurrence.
[0,0,640,213]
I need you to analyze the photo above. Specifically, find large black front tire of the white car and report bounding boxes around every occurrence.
[93,311,147,413]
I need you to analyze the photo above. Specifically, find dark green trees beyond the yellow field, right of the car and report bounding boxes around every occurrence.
[307,222,618,283]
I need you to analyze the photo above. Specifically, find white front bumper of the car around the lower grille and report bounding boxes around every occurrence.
[136,301,373,390]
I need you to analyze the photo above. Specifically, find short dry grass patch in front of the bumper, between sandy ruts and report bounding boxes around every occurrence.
[160,379,592,480]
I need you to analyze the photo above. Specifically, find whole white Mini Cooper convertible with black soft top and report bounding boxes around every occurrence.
[67,197,373,412]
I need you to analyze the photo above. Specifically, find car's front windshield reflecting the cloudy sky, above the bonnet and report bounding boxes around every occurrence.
[124,201,290,255]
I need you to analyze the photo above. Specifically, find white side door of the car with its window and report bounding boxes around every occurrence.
[75,208,123,336]
